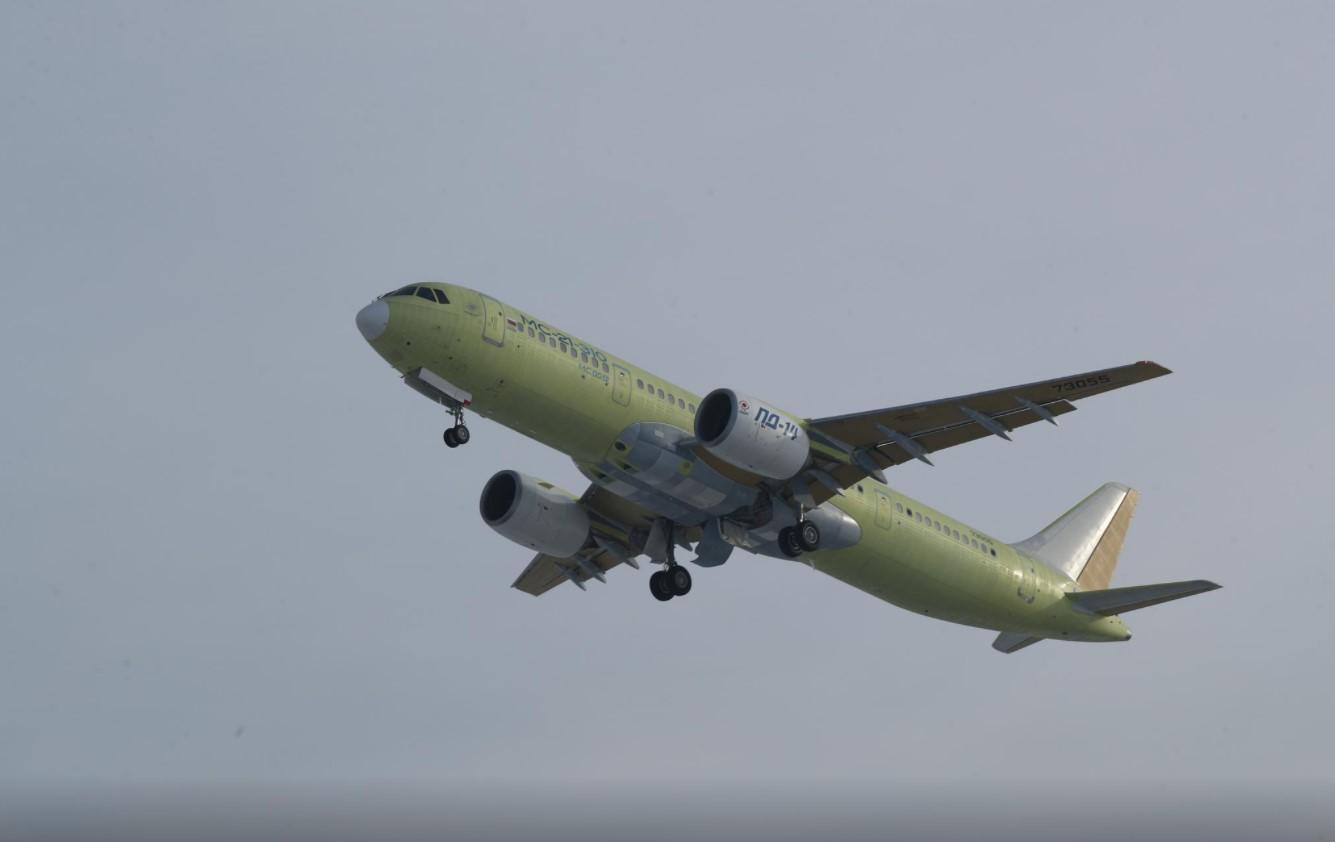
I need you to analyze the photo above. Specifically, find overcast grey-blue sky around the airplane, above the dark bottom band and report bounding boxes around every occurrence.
[0,1,1335,827]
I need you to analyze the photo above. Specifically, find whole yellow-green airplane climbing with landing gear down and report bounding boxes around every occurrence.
[356,283,1219,653]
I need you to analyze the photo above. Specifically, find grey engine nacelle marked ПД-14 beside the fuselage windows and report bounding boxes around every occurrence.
[696,388,812,479]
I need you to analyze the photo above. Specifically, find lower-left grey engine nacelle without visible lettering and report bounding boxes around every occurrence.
[478,471,589,558]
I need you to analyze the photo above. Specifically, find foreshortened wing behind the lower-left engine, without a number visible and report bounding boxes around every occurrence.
[513,486,654,596]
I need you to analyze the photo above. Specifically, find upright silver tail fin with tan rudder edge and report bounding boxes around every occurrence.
[1015,483,1140,590]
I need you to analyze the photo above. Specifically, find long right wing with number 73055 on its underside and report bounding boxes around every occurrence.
[806,362,1171,500]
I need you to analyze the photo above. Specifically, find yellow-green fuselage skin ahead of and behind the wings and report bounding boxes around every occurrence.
[371,284,1129,641]
